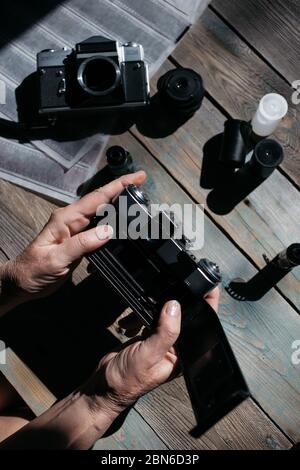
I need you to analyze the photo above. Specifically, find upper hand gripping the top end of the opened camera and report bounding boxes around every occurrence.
[1,171,146,306]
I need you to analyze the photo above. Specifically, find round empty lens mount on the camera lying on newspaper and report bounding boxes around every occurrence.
[77,56,121,96]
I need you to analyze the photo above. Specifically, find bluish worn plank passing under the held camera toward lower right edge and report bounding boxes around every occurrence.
[106,135,300,440]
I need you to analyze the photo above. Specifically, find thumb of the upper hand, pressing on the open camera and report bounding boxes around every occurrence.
[60,225,114,265]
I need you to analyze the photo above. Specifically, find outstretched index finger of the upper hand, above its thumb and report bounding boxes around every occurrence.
[69,171,146,221]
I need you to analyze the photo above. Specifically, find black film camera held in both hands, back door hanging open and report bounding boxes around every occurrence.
[88,185,249,437]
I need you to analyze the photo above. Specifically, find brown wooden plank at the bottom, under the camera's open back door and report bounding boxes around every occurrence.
[135,378,291,450]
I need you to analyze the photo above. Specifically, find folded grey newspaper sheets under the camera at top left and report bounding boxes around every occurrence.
[0,0,208,203]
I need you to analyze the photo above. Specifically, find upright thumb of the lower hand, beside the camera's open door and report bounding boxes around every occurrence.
[140,300,181,367]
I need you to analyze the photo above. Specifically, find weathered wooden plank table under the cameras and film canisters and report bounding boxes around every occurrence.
[0,0,300,449]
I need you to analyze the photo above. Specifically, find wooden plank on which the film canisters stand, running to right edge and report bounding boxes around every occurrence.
[133,63,300,309]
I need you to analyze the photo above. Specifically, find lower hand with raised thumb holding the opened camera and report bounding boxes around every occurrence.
[85,301,181,415]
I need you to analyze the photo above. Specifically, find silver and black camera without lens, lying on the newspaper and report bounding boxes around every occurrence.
[37,36,150,114]
